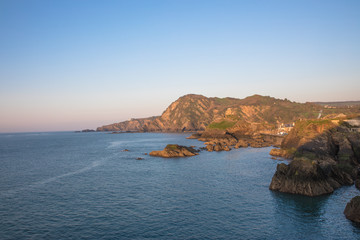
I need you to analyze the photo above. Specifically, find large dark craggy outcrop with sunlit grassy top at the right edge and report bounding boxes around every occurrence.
[269,120,360,196]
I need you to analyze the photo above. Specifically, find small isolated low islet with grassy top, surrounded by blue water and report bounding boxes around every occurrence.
[149,144,198,158]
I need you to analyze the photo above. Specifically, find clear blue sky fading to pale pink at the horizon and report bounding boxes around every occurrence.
[0,0,360,132]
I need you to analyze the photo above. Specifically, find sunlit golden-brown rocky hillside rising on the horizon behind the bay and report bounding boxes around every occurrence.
[97,94,360,134]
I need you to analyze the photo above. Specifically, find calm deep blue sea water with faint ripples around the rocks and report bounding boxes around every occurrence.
[0,133,360,239]
